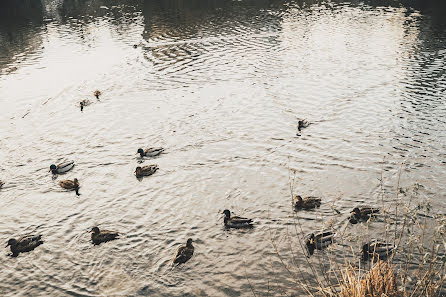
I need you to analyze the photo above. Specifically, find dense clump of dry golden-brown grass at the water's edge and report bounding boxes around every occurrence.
[337,261,401,297]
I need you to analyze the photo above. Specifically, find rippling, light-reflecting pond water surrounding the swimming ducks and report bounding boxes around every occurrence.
[0,0,446,296]
